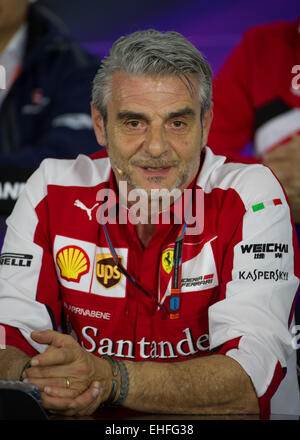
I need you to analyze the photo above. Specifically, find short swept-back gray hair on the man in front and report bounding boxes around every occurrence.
[92,29,212,122]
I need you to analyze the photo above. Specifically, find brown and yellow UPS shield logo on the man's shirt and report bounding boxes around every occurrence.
[96,254,123,289]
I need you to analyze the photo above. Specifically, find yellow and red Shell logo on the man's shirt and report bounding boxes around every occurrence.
[56,246,90,283]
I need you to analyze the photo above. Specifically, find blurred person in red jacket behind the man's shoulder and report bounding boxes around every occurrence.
[208,18,300,227]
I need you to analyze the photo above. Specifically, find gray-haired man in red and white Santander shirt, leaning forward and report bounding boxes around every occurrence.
[0,30,299,417]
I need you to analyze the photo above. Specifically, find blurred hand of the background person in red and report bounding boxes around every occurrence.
[263,135,300,223]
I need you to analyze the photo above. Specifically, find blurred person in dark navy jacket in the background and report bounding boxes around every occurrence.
[0,0,99,217]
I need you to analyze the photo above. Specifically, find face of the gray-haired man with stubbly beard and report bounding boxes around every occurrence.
[95,72,211,194]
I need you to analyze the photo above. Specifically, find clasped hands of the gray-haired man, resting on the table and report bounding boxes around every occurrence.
[24,330,111,416]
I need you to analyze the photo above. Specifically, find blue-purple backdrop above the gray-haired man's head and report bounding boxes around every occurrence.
[39,0,300,72]
